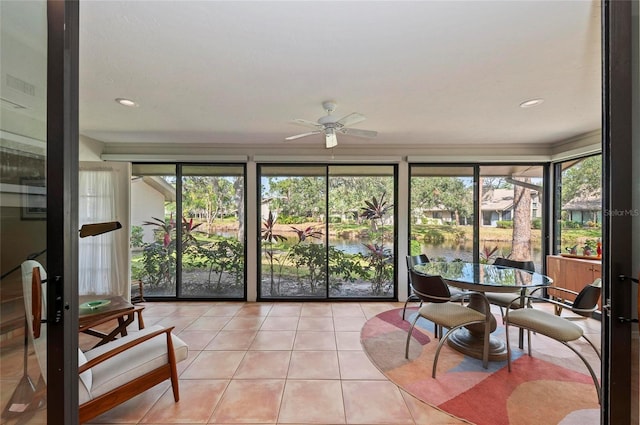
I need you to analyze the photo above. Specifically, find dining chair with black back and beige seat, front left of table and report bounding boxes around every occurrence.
[404,270,491,378]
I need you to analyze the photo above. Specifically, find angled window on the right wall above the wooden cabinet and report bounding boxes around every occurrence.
[554,155,602,258]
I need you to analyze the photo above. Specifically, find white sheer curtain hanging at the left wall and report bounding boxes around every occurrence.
[78,168,126,295]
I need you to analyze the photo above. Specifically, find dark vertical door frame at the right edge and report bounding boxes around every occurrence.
[601,0,638,424]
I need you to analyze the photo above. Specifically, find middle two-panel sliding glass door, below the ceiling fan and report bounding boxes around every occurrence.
[259,165,396,299]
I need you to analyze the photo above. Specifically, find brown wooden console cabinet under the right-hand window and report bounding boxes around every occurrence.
[547,255,602,311]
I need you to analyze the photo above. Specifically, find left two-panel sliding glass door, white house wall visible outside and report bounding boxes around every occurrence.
[131,164,246,299]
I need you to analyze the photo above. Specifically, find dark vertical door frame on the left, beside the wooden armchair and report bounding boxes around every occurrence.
[46,0,79,424]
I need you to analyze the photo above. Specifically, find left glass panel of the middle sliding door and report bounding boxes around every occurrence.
[258,165,327,298]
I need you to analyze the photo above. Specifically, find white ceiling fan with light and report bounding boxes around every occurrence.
[285,102,378,149]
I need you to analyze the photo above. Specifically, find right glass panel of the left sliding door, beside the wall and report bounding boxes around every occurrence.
[180,165,245,299]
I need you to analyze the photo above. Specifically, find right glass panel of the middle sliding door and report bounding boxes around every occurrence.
[327,165,396,298]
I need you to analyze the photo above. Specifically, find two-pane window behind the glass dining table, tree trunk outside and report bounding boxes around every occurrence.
[409,164,544,271]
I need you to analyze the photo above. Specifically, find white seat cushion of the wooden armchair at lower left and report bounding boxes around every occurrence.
[84,325,189,398]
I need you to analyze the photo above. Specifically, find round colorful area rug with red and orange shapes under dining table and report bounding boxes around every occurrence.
[361,308,600,425]
